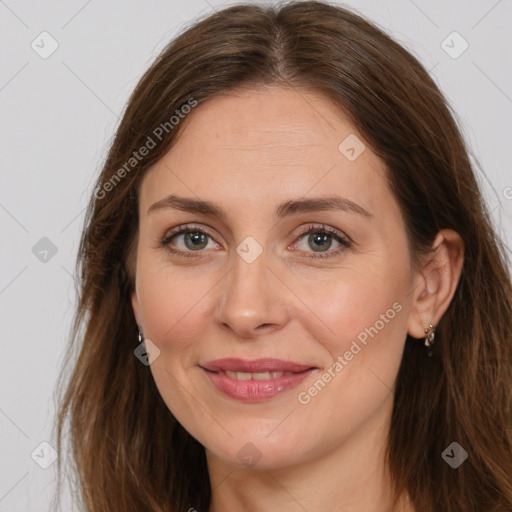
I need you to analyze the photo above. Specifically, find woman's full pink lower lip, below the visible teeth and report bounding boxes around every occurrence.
[201,368,315,402]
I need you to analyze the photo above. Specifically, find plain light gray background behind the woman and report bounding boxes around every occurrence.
[0,0,512,512]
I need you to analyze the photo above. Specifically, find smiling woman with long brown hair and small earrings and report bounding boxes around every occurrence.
[52,2,512,512]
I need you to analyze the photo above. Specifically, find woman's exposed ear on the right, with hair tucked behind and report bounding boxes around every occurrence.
[407,229,464,339]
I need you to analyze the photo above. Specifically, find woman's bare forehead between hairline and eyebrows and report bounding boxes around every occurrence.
[141,86,389,216]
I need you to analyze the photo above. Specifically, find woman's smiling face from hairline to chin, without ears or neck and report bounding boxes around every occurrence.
[132,87,420,468]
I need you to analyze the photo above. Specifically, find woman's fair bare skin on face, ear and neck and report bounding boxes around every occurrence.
[131,86,463,512]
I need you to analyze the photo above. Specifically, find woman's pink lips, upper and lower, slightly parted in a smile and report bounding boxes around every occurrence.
[200,358,316,402]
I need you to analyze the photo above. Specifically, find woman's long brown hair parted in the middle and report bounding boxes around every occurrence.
[52,1,512,512]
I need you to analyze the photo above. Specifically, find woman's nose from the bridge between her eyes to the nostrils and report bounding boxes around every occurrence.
[217,237,286,336]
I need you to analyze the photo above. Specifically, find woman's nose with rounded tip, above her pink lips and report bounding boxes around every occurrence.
[216,245,289,338]
